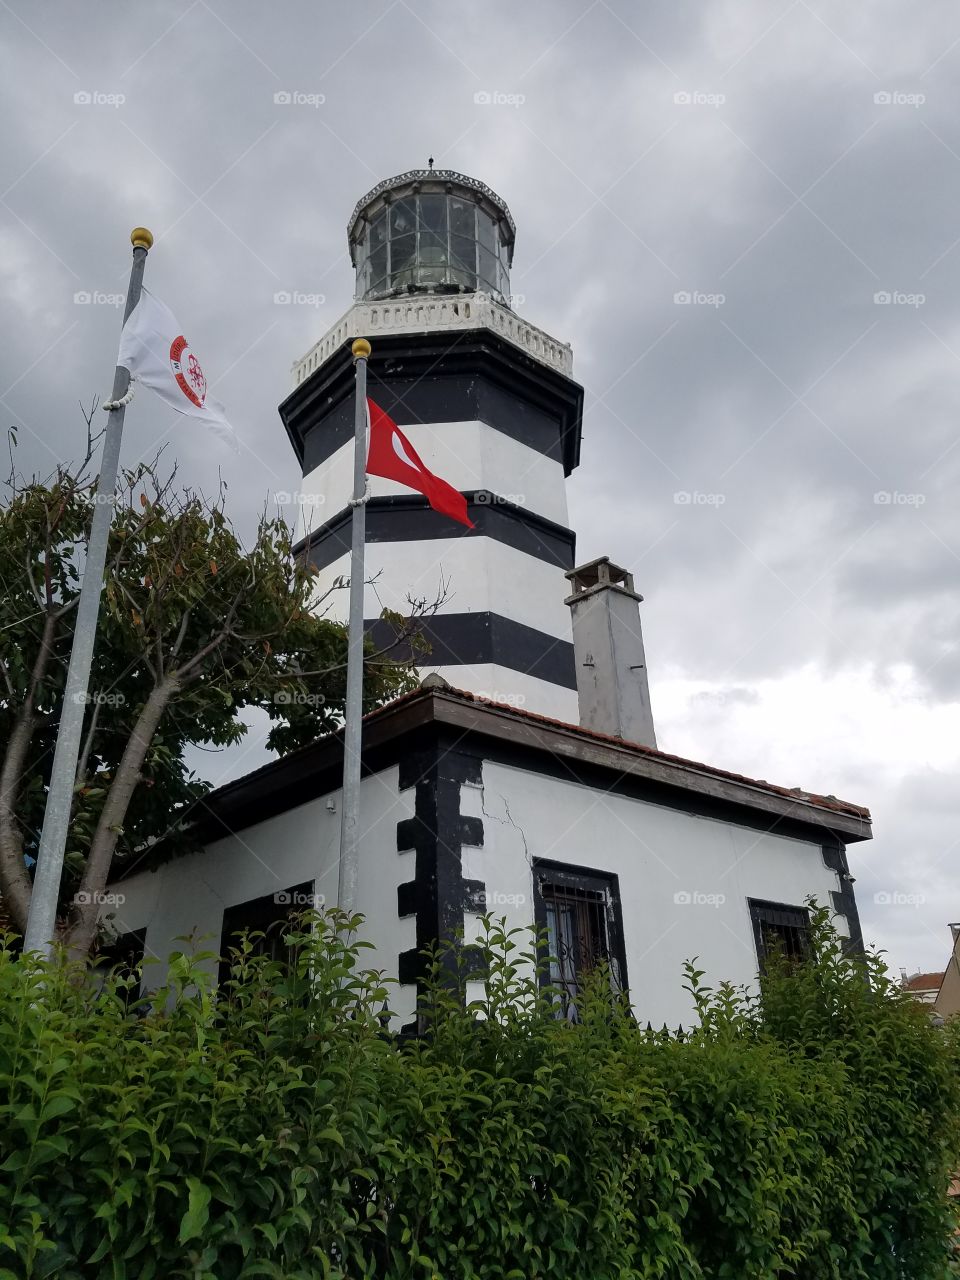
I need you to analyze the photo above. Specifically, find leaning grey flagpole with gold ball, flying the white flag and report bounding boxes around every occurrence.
[23,227,154,956]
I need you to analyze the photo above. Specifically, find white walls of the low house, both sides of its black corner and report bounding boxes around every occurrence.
[113,760,846,1027]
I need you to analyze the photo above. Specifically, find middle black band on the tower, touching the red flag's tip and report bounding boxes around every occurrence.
[294,489,576,573]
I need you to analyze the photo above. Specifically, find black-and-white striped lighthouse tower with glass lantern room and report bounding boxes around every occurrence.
[273,165,584,722]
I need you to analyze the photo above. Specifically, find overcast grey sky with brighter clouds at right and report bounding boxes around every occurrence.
[0,0,960,972]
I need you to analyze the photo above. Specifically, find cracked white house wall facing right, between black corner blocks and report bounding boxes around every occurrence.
[462,760,846,1027]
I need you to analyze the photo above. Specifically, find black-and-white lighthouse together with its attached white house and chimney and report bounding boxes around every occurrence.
[104,168,870,1024]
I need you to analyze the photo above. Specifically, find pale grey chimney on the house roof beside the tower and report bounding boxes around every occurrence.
[567,556,657,748]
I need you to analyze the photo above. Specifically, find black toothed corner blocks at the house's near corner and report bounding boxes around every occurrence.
[397,741,486,1029]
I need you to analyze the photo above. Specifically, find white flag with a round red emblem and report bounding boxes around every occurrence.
[116,289,239,453]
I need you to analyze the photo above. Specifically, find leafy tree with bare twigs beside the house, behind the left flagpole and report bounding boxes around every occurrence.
[0,422,416,955]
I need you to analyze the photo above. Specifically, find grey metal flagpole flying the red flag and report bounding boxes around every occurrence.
[337,338,370,915]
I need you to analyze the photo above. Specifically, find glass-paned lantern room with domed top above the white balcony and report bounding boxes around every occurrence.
[347,163,516,306]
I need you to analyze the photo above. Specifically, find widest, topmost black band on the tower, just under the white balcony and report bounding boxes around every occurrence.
[279,329,584,475]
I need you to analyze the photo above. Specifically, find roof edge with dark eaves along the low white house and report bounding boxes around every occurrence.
[118,680,872,876]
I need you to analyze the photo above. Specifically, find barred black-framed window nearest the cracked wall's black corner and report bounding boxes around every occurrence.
[534,859,627,1021]
